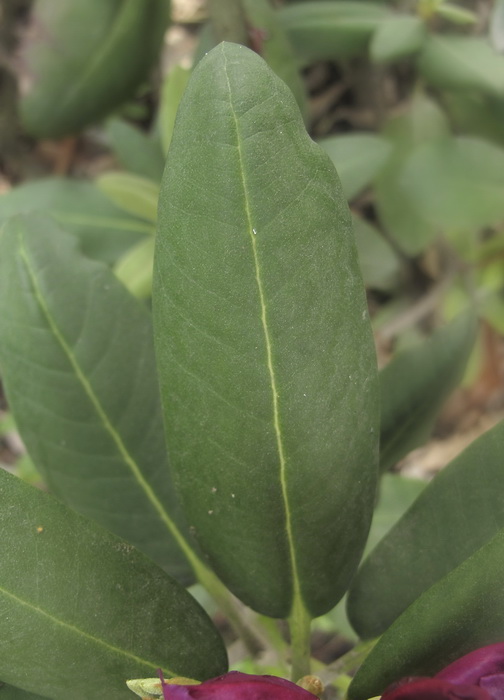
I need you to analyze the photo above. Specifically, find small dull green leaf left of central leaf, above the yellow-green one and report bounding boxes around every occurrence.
[105,118,165,182]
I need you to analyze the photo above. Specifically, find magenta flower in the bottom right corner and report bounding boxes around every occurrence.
[382,643,504,700]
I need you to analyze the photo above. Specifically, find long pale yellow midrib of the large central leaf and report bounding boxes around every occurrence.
[226,58,304,609]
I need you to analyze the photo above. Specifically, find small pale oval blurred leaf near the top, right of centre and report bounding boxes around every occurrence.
[369,15,427,63]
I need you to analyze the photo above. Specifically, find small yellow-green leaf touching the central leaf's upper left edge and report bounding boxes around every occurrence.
[95,173,159,224]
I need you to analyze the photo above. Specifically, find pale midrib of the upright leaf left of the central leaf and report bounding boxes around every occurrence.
[20,242,202,569]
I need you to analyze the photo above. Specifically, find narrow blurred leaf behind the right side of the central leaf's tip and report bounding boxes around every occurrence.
[242,0,308,119]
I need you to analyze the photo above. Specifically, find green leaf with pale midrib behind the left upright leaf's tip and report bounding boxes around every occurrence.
[0,178,153,262]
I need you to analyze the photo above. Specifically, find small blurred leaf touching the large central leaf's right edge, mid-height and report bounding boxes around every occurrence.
[352,214,400,292]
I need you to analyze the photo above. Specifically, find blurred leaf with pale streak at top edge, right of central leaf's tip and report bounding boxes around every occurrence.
[278,0,391,63]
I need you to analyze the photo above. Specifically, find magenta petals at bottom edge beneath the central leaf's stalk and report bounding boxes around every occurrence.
[161,671,316,700]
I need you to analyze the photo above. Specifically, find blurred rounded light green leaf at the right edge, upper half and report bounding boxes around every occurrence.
[402,137,504,233]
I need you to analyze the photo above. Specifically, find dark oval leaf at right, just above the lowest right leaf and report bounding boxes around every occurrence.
[349,423,504,637]
